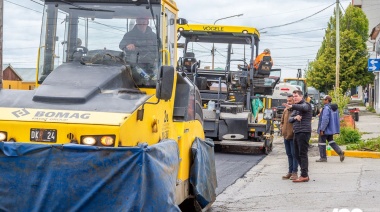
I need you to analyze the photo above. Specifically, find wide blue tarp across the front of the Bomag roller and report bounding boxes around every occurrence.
[0,140,179,212]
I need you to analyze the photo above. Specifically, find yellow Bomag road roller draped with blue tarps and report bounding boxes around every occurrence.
[0,0,216,211]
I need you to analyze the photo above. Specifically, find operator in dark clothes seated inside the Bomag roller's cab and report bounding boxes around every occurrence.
[119,16,158,85]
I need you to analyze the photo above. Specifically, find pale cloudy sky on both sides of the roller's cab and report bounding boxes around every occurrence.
[3,0,351,76]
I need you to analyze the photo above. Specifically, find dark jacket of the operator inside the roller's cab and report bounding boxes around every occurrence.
[119,26,158,63]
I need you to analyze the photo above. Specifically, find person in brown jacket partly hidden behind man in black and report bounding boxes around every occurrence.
[281,95,298,180]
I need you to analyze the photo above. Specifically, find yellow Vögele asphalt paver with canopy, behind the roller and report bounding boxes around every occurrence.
[177,24,281,154]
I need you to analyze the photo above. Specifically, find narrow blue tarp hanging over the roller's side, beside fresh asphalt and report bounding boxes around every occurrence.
[190,138,217,208]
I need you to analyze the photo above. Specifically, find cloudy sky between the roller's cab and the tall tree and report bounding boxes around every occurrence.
[177,0,351,77]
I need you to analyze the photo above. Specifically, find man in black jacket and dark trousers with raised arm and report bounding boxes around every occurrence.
[285,90,313,183]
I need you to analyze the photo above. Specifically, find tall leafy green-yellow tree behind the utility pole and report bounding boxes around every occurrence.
[306,5,373,92]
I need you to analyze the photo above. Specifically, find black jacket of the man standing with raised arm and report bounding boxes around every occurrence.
[289,100,313,133]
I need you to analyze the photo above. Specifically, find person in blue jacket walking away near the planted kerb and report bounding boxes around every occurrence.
[316,95,344,162]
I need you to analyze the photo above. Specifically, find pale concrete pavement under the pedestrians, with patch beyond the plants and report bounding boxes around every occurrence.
[210,104,380,212]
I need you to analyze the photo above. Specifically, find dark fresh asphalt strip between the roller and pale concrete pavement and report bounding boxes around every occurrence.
[215,152,265,195]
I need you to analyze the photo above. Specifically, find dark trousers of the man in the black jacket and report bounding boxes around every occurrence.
[294,132,311,177]
